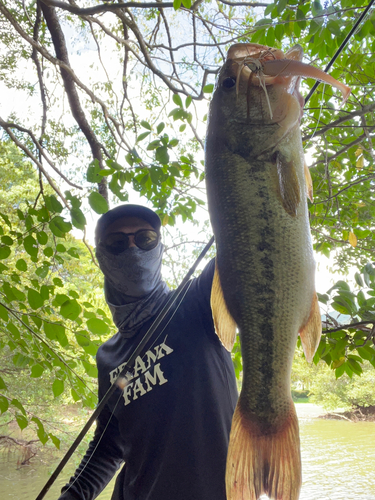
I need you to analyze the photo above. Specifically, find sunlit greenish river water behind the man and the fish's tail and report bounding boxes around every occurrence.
[0,404,375,500]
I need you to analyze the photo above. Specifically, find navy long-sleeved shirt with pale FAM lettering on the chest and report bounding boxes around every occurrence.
[60,261,237,500]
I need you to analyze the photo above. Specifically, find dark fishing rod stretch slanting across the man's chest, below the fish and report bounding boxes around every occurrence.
[35,236,215,500]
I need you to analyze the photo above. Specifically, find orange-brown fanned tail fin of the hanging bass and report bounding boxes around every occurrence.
[225,401,302,500]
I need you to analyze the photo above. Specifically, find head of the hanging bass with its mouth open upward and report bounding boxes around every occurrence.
[209,43,304,137]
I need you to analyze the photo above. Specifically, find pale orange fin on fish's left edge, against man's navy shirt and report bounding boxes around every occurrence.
[211,263,236,352]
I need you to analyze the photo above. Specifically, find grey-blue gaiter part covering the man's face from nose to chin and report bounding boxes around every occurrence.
[96,243,164,298]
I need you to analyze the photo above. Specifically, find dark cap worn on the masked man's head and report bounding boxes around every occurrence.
[95,204,161,245]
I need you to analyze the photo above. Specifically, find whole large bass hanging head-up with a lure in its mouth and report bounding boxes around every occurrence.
[205,43,350,500]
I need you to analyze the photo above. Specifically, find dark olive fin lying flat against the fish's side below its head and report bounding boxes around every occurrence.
[276,152,301,217]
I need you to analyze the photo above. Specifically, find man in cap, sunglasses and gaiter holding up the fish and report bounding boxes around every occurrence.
[59,205,237,500]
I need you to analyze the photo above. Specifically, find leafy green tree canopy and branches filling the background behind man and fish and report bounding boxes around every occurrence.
[0,0,375,446]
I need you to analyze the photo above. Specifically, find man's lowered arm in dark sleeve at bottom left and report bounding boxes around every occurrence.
[58,407,123,500]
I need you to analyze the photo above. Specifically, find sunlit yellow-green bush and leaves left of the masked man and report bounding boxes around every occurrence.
[0,143,113,446]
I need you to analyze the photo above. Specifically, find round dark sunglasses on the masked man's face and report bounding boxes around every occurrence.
[100,229,160,255]
